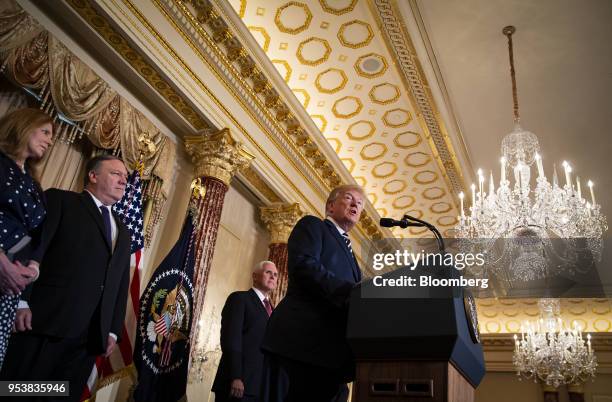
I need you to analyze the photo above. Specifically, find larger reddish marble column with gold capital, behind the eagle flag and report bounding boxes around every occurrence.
[185,128,254,346]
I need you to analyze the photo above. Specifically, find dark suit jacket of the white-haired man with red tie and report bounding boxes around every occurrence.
[212,289,268,396]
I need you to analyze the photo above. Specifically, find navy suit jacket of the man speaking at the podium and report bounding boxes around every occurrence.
[262,216,361,377]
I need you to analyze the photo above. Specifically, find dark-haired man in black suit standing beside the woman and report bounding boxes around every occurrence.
[0,155,130,401]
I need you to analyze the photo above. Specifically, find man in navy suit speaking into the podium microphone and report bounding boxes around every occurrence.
[262,185,365,402]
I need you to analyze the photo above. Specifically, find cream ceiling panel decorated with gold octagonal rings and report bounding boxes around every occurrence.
[230,0,458,237]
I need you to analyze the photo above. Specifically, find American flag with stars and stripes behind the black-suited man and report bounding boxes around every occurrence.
[81,169,144,401]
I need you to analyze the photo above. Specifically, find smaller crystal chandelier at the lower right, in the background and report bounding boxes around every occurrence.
[512,299,597,388]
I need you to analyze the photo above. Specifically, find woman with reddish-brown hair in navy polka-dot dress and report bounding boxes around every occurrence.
[0,108,53,367]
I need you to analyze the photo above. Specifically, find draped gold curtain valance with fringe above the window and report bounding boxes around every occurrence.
[0,1,176,197]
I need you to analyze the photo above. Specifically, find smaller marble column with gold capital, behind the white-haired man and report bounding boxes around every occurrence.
[260,203,304,306]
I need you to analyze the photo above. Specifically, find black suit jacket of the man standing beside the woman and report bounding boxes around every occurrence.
[23,189,130,352]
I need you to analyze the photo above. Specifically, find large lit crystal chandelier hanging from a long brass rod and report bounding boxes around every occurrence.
[455,26,608,280]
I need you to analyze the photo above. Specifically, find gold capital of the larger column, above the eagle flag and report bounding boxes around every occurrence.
[185,128,255,186]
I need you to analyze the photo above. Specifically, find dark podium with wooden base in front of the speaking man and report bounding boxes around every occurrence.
[347,268,485,402]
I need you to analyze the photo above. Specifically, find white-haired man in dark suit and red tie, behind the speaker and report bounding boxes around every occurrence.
[212,261,278,402]
